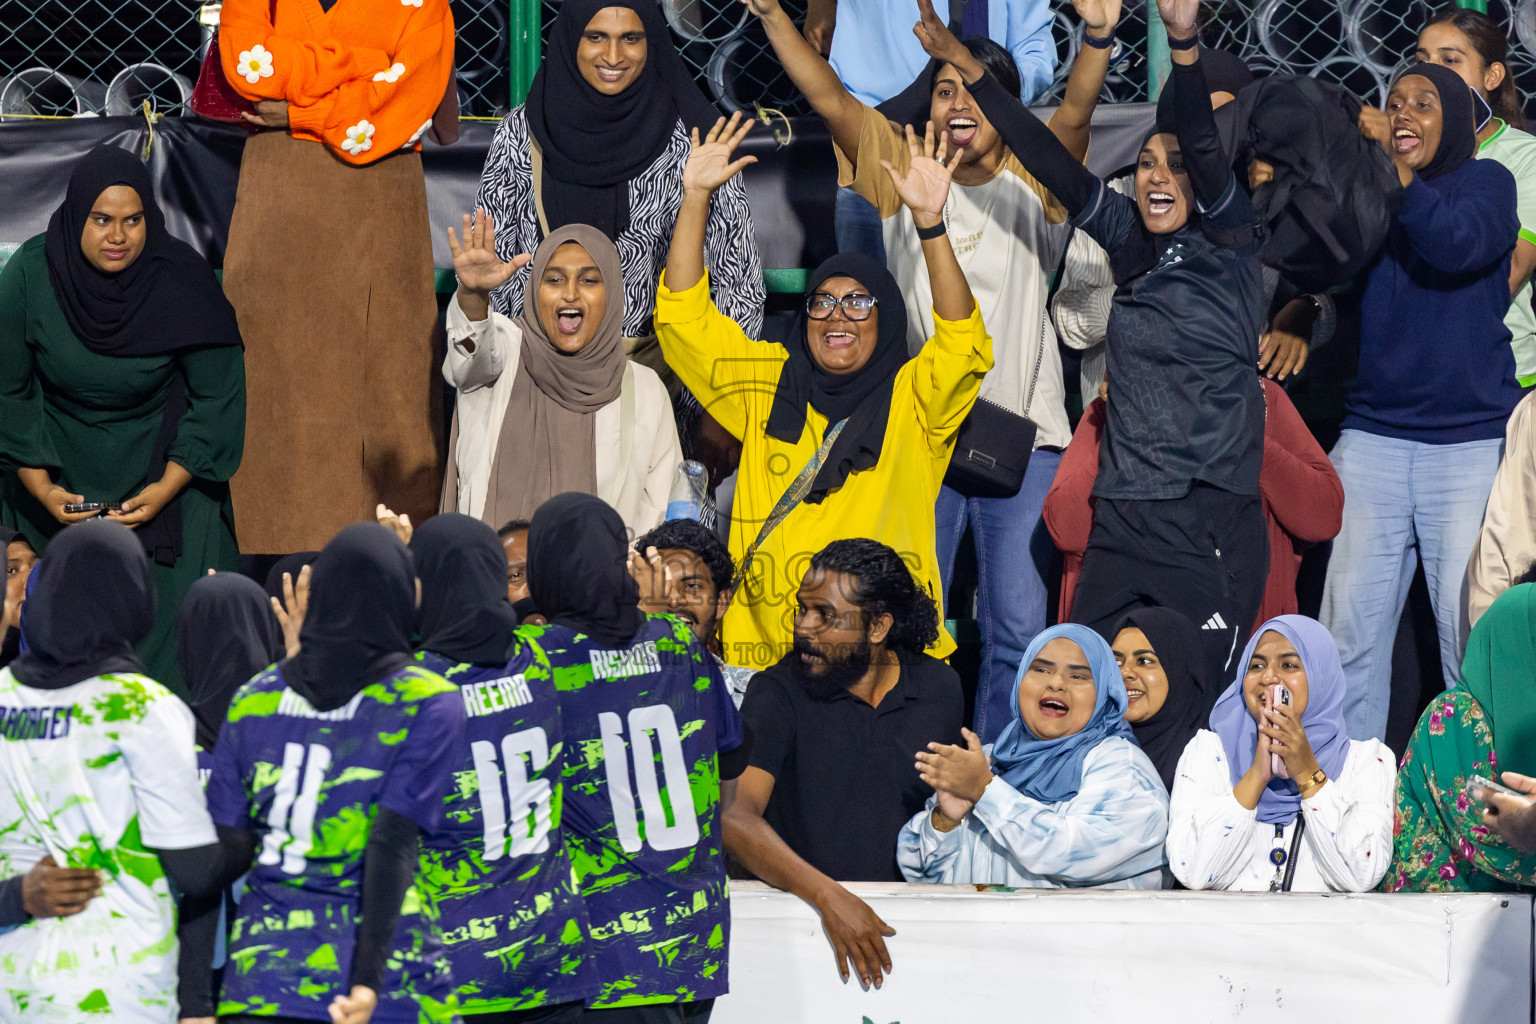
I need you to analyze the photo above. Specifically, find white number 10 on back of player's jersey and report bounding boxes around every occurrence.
[598,705,699,854]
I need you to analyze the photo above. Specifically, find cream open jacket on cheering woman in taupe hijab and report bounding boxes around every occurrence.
[442,292,682,536]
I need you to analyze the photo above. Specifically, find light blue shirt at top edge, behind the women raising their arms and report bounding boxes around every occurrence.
[831,0,1057,106]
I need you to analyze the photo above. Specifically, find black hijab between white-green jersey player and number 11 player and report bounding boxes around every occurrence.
[177,573,283,768]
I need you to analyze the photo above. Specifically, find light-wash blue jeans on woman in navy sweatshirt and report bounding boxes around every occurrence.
[1319,430,1504,740]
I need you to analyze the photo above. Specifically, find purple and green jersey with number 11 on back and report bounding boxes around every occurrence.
[207,665,464,1024]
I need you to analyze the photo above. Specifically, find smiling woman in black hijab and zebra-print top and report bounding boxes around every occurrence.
[473,0,766,376]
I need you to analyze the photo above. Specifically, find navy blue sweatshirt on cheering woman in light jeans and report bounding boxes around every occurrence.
[1344,160,1522,444]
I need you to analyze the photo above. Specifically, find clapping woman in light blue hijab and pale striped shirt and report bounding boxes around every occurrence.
[895,625,1167,889]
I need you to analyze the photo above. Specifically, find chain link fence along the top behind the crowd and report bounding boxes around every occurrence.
[9,0,1536,117]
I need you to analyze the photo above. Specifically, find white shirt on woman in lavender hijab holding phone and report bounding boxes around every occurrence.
[1167,729,1398,892]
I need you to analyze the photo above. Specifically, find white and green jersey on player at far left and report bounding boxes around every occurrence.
[0,668,215,1024]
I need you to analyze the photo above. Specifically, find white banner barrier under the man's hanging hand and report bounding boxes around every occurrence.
[711,883,1531,1024]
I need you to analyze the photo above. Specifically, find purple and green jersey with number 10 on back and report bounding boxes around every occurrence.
[522,616,742,1007]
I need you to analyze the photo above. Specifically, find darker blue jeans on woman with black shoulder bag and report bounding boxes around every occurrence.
[934,451,1061,743]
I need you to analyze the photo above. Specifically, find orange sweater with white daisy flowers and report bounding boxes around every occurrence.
[218,0,453,164]
